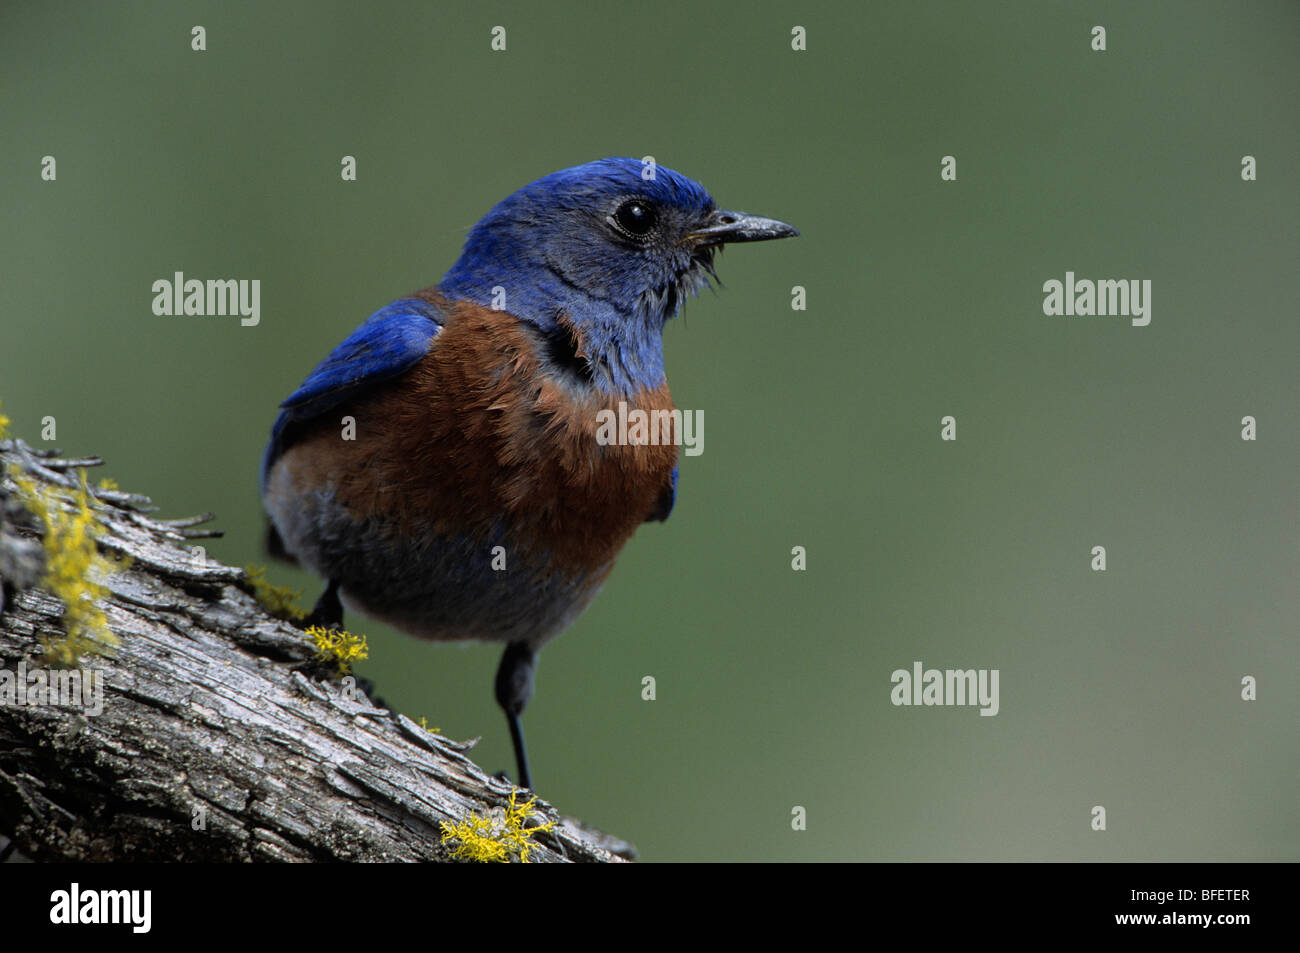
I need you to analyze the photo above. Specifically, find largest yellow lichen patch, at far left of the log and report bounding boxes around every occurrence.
[9,465,126,668]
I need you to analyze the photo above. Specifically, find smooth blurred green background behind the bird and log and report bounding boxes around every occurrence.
[0,0,1300,861]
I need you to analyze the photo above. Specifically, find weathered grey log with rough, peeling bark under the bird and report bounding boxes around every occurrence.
[0,439,634,862]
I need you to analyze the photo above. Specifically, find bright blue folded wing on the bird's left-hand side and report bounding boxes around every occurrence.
[261,298,445,491]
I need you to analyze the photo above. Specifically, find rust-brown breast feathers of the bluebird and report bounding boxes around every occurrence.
[280,302,677,575]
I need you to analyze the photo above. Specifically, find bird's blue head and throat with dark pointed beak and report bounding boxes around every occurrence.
[439,159,798,394]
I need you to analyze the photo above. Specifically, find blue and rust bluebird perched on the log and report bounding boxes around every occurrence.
[261,159,798,788]
